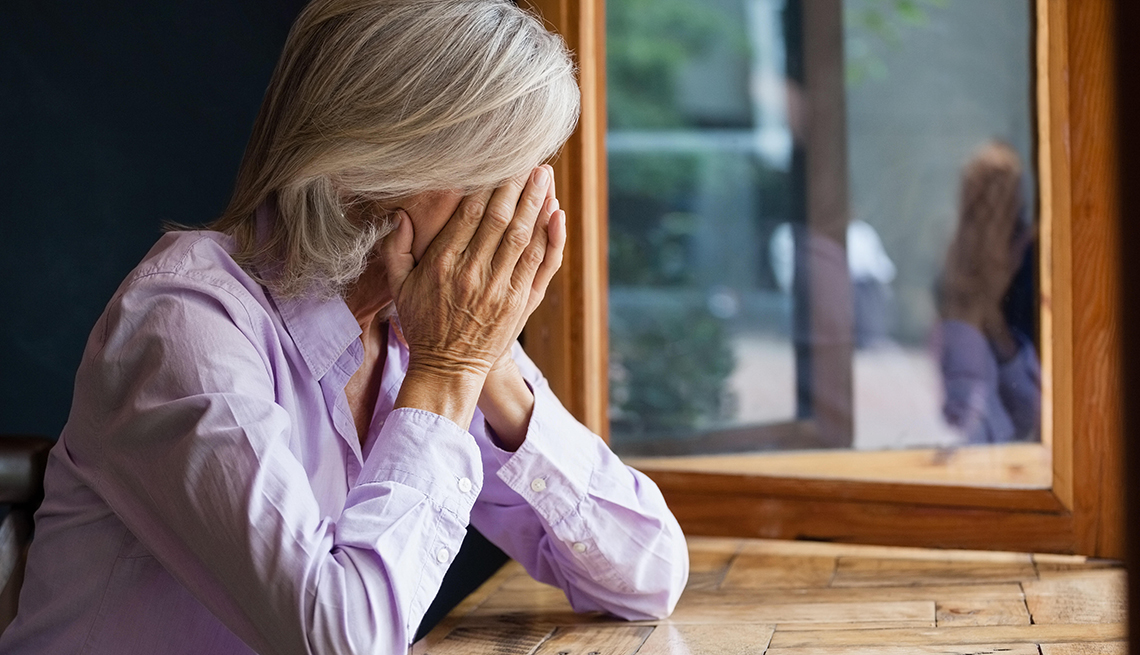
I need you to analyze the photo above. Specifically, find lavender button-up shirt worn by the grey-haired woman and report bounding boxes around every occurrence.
[0,232,689,655]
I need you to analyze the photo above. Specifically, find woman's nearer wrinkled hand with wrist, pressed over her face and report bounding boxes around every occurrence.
[383,166,565,425]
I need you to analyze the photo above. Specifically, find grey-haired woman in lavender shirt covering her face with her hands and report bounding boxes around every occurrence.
[0,0,687,655]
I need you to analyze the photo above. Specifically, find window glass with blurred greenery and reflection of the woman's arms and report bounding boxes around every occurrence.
[606,0,1040,455]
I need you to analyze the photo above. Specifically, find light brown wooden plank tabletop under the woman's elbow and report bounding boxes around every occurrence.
[413,538,1127,655]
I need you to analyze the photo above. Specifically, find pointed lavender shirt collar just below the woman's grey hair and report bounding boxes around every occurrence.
[257,203,360,379]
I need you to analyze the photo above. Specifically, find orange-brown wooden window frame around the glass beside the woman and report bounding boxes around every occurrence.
[527,0,1124,558]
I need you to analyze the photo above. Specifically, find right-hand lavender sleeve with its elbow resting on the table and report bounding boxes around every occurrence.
[471,346,689,620]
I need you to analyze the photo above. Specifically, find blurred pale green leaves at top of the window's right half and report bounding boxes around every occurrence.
[845,0,946,87]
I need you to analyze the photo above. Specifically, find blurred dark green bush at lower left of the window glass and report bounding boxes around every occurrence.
[610,309,735,439]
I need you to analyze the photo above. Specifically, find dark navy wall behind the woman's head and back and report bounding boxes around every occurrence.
[0,0,303,436]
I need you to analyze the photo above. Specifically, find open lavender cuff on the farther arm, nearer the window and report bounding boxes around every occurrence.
[495,386,601,525]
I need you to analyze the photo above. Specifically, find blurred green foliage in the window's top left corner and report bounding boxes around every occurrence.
[605,0,732,130]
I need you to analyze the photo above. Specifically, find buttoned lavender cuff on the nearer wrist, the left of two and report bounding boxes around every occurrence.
[357,408,483,525]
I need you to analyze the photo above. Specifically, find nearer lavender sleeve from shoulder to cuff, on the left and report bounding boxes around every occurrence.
[67,276,483,654]
